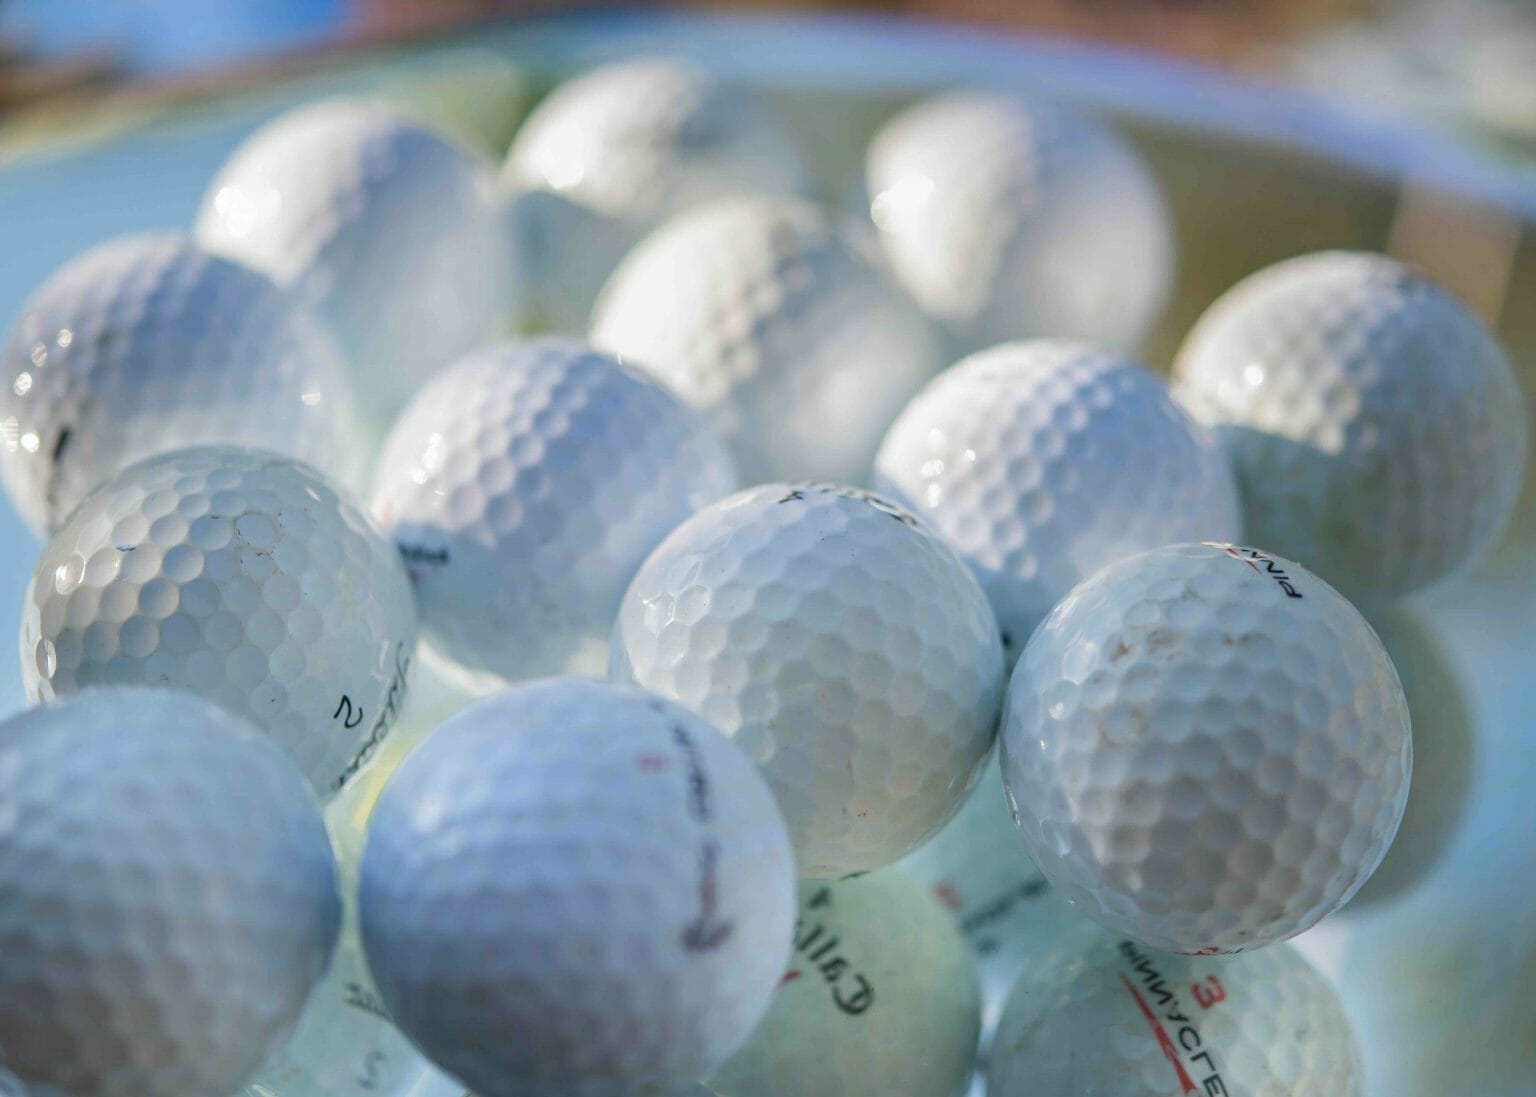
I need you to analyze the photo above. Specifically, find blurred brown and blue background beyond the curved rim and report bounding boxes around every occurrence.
[0,0,1536,155]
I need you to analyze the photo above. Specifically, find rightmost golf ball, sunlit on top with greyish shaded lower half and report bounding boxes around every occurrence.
[1175,252,1528,599]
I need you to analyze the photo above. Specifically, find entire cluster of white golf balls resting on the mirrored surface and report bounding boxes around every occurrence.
[0,47,1527,1097]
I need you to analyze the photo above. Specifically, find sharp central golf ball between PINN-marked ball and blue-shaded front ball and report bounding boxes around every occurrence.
[611,484,1003,877]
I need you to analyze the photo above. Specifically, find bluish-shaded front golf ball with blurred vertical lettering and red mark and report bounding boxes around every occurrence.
[359,679,794,1097]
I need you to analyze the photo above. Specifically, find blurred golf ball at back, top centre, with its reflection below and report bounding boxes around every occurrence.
[504,58,811,332]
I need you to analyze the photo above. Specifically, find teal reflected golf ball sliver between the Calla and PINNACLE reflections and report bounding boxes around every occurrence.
[897,752,1098,1059]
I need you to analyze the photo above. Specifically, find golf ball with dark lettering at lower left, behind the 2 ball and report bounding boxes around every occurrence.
[373,340,736,681]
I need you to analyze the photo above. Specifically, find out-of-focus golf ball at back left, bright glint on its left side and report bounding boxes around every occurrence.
[197,100,516,432]
